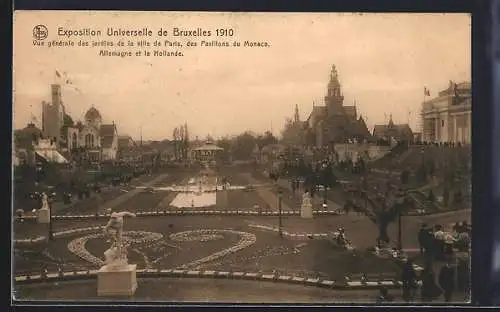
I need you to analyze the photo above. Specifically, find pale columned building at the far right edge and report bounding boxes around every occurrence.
[422,80,472,144]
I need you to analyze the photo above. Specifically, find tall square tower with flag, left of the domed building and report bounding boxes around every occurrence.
[42,84,66,146]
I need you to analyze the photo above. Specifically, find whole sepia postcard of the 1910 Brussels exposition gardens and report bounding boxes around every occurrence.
[12,11,472,305]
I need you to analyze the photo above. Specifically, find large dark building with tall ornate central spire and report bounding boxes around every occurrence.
[306,65,371,147]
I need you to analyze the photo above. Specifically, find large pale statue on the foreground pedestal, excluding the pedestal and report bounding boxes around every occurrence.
[104,211,135,266]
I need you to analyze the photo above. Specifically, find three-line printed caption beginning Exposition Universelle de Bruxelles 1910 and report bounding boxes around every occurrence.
[33,27,271,57]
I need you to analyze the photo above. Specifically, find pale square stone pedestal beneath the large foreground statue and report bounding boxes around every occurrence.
[97,264,137,296]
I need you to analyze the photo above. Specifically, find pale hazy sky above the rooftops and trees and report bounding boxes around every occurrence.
[13,11,471,139]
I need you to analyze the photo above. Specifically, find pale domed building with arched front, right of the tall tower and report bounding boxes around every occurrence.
[67,106,118,163]
